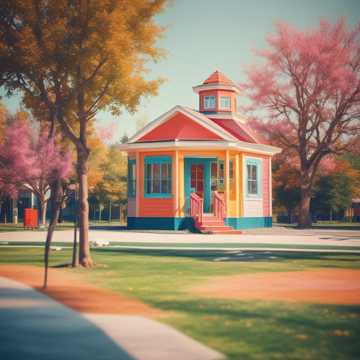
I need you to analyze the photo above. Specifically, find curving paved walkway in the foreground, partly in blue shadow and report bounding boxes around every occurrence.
[0,277,224,360]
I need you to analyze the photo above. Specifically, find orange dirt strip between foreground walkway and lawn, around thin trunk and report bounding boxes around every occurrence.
[0,265,161,317]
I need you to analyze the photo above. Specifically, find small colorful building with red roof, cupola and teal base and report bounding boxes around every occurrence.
[121,71,280,233]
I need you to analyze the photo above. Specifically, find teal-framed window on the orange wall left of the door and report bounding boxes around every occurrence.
[144,156,172,198]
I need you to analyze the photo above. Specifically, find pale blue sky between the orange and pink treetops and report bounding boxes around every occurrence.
[2,0,360,141]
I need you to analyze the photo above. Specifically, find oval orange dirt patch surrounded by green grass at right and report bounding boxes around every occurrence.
[194,269,360,305]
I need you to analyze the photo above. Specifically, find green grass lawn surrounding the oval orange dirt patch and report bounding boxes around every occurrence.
[0,247,360,360]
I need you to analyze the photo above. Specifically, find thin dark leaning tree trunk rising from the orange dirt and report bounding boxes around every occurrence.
[43,179,62,289]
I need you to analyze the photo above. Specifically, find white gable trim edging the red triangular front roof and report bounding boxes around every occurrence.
[128,105,237,143]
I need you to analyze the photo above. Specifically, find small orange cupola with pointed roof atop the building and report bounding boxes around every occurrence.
[193,70,240,118]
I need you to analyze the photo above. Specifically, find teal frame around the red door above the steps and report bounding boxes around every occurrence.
[184,156,217,214]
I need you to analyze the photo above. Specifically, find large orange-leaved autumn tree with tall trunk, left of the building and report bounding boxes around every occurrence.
[0,0,166,267]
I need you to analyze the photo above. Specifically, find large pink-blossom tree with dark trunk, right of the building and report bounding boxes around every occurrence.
[244,20,360,227]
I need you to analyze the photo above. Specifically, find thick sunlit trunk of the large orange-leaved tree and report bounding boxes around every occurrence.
[77,149,93,267]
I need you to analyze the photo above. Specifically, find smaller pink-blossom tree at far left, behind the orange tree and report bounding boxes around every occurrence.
[0,113,72,226]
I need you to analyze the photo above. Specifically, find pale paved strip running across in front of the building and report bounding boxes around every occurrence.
[0,227,360,246]
